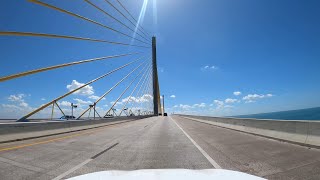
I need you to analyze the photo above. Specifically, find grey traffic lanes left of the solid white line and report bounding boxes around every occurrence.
[0,117,213,179]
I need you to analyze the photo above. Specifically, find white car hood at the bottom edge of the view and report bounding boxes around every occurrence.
[70,169,263,180]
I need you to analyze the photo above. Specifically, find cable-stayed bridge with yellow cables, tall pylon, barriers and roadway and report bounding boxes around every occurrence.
[0,0,320,179]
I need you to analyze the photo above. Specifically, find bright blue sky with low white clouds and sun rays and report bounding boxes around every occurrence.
[0,0,320,118]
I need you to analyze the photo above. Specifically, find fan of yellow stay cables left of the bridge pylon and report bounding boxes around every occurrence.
[0,0,157,122]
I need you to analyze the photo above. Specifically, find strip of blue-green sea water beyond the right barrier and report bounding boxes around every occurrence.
[232,107,320,121]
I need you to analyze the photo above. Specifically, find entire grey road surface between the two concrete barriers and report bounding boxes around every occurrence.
[0,116,320,180]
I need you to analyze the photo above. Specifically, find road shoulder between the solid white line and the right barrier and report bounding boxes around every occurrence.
[173,116,320,180]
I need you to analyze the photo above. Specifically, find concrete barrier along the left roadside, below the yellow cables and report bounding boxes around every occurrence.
[0,116,151,143]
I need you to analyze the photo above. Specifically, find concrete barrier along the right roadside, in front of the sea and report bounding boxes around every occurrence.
[178,115,320,147]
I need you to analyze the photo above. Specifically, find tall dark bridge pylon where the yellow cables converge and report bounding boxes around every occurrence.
[152,37,161,116]
